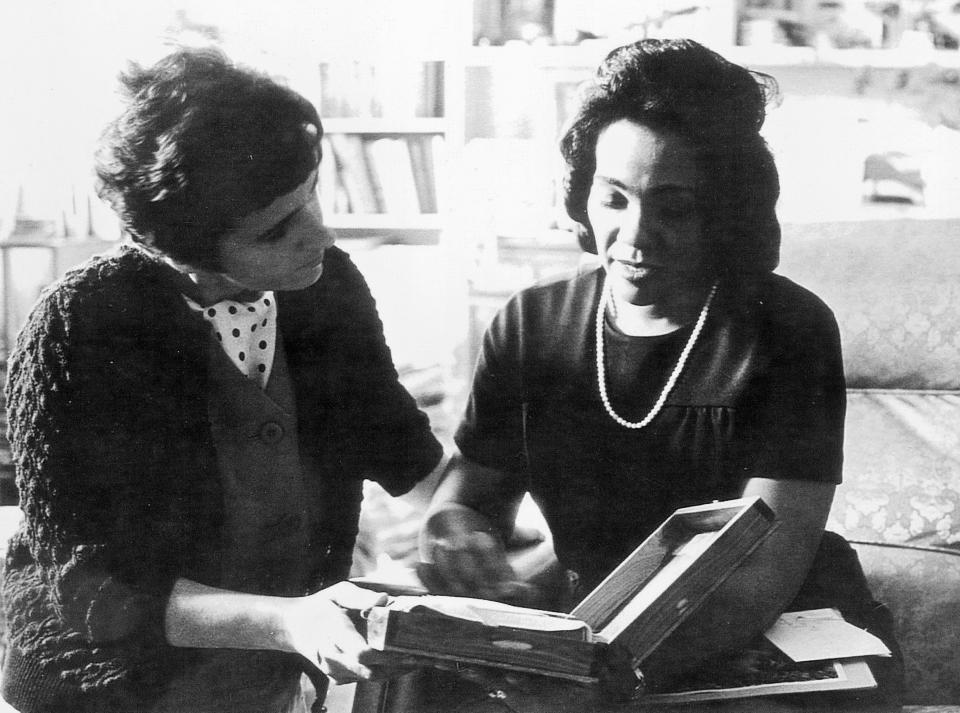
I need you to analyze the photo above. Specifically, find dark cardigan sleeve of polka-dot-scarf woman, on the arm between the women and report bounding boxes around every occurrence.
[312,249,443,495]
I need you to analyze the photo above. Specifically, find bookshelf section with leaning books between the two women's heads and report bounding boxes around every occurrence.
[316,57,449,244]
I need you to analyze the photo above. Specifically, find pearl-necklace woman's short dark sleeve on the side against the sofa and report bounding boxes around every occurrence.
[735,286,846,483]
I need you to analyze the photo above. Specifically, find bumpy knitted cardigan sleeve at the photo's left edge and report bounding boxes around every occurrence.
[5,292,175,645]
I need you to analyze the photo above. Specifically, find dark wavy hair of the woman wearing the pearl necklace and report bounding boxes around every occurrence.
[560,39,780,273]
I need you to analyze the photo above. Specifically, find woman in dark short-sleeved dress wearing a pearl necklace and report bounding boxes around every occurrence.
[422,40,898,696]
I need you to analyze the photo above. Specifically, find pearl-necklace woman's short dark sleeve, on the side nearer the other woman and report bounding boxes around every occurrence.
[454,294,526,473]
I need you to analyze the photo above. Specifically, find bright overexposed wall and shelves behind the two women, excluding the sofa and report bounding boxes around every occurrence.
[0,0,960,596]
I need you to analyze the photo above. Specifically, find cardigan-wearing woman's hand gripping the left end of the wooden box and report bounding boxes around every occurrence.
[281,582,417,684]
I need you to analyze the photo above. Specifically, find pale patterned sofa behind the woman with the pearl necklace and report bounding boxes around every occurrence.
[778,219,960,711]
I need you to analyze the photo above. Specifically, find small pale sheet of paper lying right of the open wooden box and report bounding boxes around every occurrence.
[765,609,890,662]
